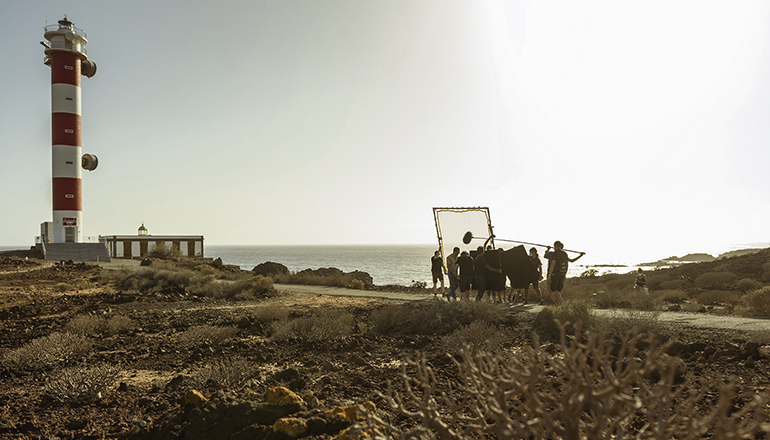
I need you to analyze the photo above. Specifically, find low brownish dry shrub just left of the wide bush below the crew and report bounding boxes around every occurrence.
[272,309,355,342]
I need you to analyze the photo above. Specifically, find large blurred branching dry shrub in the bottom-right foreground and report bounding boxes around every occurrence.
[362,327,770,440]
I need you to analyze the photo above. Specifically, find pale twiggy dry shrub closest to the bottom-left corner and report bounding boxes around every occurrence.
[43,365,120,403]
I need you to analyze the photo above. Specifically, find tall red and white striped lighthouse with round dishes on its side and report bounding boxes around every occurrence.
[41,16,97,243]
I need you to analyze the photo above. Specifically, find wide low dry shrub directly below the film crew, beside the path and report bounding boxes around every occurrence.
[372,301,504,335]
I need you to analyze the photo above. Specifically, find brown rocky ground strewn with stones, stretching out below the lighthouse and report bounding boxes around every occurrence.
[0,256,770,439]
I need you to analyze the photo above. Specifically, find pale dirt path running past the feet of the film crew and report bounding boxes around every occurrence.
[275,284,770,331]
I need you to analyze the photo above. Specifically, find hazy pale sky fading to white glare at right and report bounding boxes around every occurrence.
[0,0,770,262]
